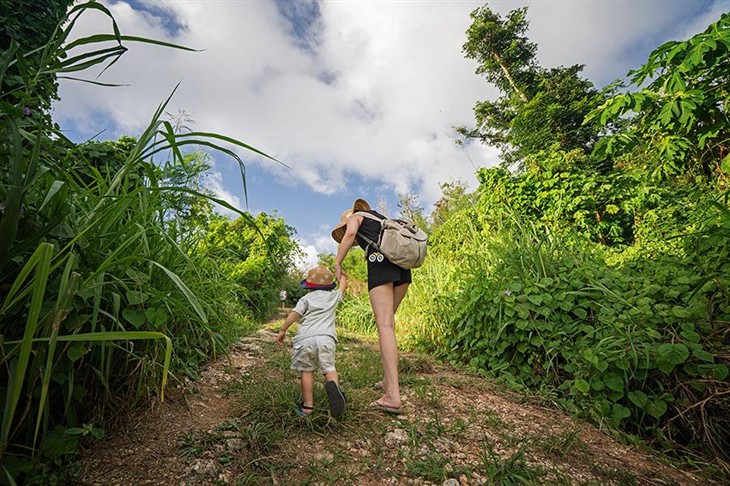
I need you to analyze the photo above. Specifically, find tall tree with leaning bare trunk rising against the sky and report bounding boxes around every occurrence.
[458,6,610,165]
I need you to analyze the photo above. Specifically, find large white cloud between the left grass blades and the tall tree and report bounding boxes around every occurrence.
[56,2,496,205]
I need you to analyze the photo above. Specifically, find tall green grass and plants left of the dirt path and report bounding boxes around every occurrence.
[0,2,278,483]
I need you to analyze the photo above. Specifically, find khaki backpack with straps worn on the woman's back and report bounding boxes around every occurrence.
[353,211,428,269]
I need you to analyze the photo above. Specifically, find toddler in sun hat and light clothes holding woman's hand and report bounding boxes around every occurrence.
[276,267,347,417]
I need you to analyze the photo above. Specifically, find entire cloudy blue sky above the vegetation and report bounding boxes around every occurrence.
[54,0,730,268]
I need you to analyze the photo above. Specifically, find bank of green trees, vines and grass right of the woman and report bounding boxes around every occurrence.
[342,7,730,475]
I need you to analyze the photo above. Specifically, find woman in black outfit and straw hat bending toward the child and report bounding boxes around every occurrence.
[332,199,411,413]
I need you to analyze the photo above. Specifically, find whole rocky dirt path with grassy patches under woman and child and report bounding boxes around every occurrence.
[79,318,709,486]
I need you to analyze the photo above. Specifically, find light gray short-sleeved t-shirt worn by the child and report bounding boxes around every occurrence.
[292,290,342,343]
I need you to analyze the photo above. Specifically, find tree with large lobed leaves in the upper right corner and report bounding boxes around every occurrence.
[586,13,730,179]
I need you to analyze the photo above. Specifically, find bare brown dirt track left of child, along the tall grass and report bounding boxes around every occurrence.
[80,332,269,486]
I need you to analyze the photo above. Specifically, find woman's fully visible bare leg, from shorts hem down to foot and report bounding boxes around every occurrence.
[370,282,402,408]
